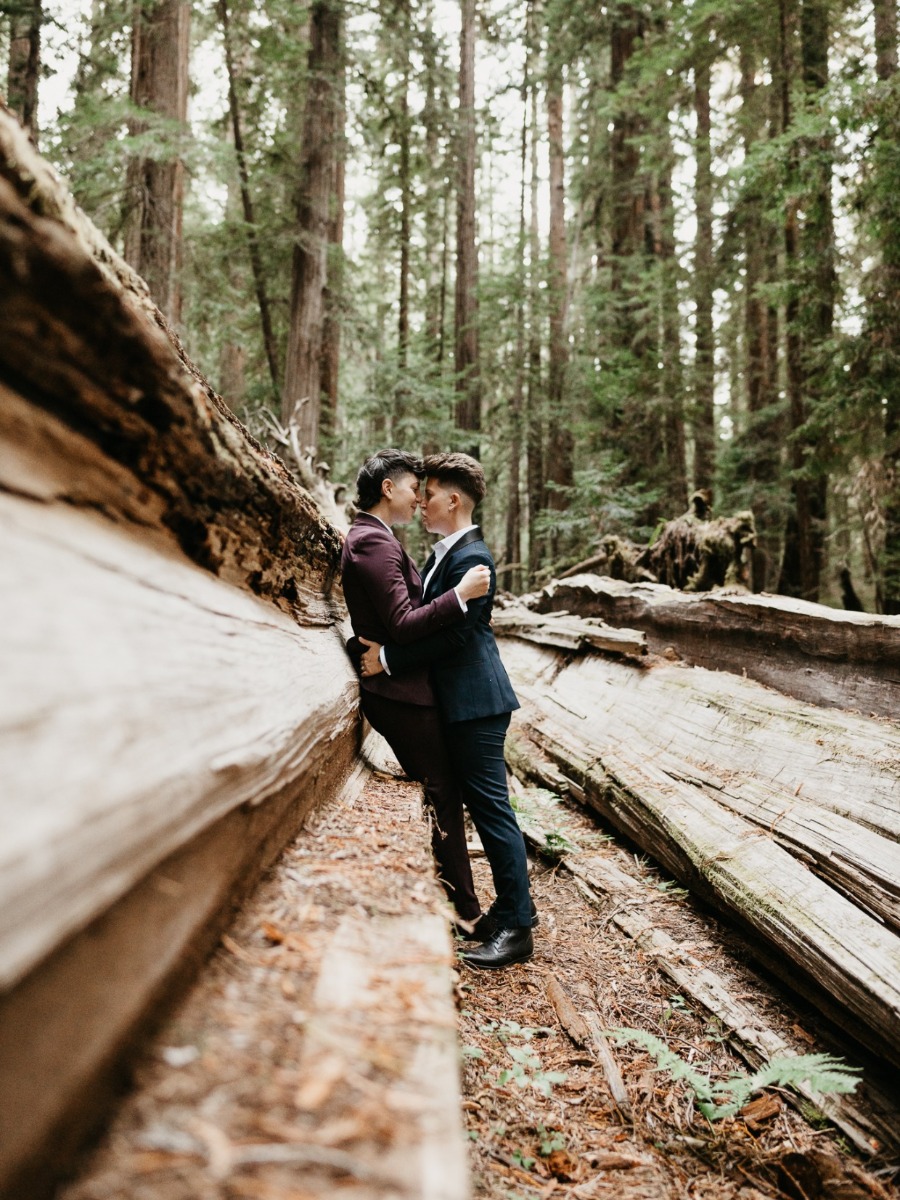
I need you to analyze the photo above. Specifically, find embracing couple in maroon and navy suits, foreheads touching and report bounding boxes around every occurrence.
[341,450,538,970]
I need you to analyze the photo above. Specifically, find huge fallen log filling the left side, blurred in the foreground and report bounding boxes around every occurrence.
[0,110,359,1200]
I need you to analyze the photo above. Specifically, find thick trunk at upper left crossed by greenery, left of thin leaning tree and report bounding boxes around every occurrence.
[125,0,191,324]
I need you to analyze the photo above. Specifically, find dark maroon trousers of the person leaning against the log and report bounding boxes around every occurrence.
[360,689,481,920]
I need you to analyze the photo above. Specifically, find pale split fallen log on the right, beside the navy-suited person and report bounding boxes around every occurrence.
[503,638,900,1064]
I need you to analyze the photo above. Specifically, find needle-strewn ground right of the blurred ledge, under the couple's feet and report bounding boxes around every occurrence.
[460,777,900,1200]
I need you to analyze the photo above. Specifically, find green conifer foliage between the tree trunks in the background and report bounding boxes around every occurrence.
[35,0,900,605]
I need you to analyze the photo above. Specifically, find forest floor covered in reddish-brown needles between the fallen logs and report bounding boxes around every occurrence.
[61,748,900,1200]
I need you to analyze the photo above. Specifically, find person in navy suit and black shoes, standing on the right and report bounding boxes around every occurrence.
[360,454,536,970]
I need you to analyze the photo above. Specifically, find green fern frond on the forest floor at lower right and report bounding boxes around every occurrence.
[610,1028,859,1121]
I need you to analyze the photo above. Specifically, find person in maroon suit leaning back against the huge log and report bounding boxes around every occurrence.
[341,450,491,937]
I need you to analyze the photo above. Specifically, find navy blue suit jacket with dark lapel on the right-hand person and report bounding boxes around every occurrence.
[377,526,520,724]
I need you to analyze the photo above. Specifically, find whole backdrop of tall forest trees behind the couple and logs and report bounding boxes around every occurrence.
[0,0,900,613]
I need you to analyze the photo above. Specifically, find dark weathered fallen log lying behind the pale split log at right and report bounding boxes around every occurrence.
[523,575,900,718]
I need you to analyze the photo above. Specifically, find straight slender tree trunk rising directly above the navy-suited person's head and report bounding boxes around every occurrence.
[454,0,481,457]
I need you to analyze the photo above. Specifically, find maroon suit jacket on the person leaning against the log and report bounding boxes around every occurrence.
[341,512,466,704]
